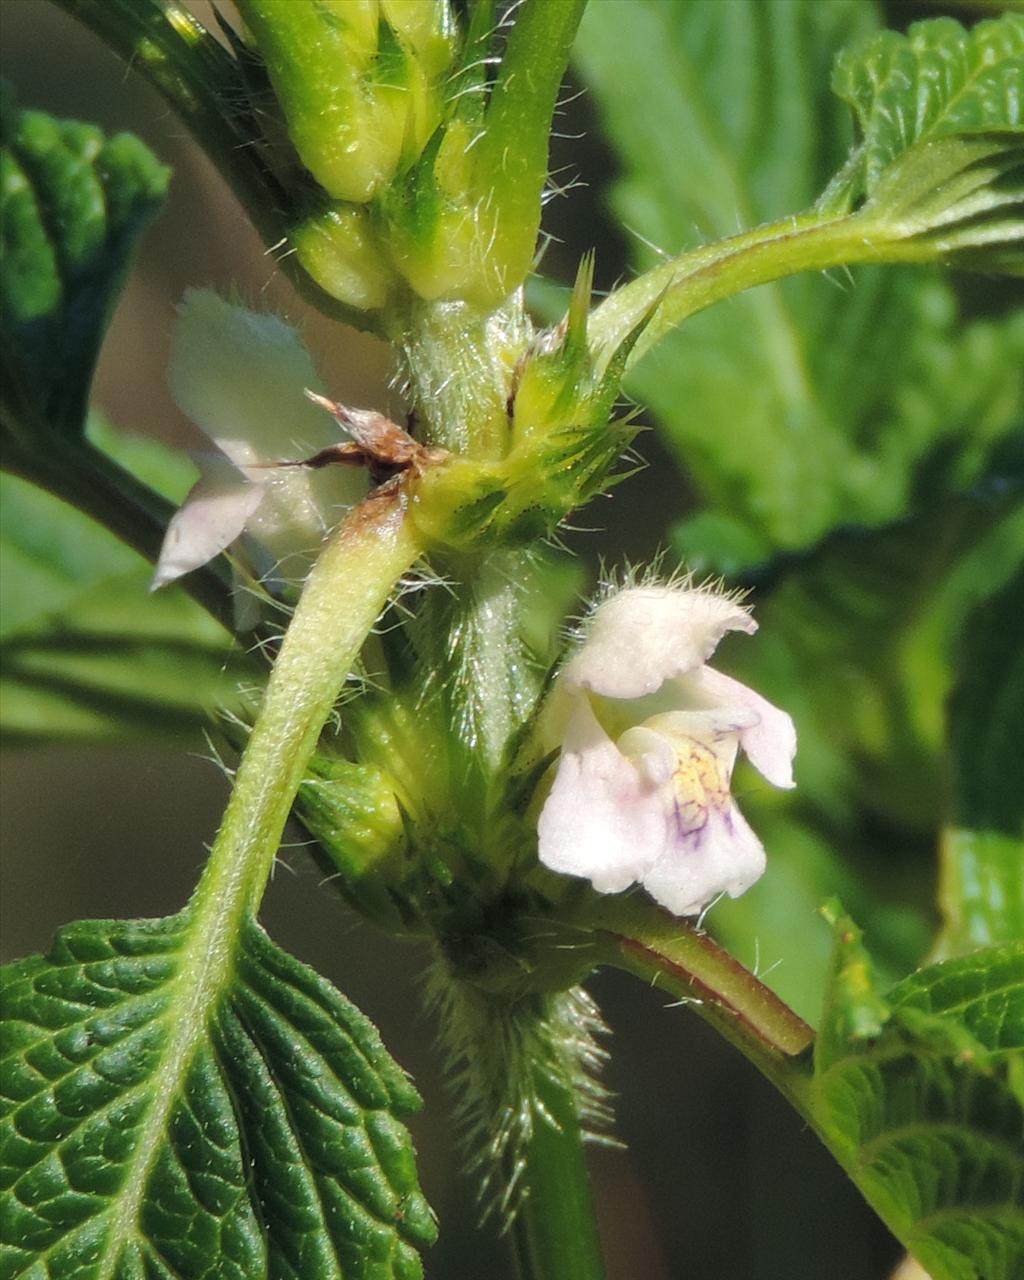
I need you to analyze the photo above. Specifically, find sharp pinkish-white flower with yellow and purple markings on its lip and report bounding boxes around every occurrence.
[538,586,796,915]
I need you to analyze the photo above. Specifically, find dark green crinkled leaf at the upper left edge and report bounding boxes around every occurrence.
[0,87,169,449]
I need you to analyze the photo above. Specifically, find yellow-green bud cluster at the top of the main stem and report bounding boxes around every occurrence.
[238,0,580,312]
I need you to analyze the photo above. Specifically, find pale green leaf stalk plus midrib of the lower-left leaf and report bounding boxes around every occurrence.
[90,495,420,1280]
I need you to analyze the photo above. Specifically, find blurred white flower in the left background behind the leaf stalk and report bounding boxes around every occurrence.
[152,289,366,590]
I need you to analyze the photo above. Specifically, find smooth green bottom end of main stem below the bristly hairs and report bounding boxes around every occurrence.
[512,1078,604,1280]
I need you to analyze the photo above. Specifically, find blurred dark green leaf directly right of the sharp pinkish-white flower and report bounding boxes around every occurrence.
[736,475,1024,833]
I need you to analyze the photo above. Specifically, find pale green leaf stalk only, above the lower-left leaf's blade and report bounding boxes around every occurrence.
[193,495,421,945]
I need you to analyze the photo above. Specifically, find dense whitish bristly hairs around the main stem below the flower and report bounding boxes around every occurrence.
[426,951,618,1233]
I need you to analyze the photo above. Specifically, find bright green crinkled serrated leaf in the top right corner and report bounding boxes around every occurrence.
[820,13,1024,274]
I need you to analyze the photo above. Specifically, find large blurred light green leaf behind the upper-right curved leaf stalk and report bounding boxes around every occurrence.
[576,0,872,559]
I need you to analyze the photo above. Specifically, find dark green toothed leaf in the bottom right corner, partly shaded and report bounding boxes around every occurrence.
[812,915,1024,1280]
